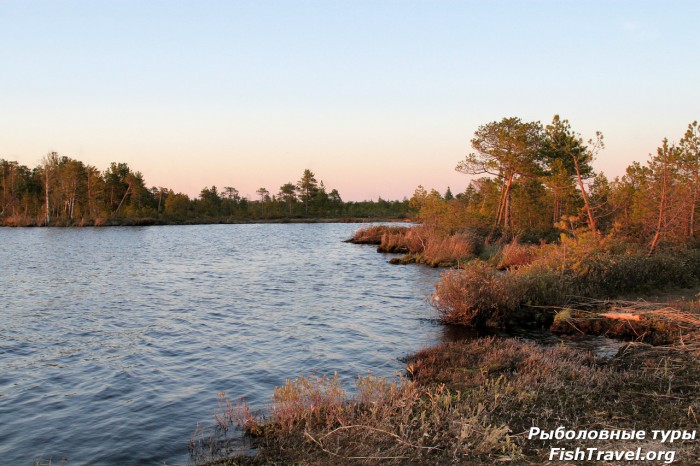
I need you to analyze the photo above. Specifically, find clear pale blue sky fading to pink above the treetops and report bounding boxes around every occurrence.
[0,0,700,201]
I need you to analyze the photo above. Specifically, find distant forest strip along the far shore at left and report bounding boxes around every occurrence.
[0,159,409,226]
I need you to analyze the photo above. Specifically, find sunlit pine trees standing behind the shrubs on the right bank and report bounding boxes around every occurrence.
[410,115,700,254]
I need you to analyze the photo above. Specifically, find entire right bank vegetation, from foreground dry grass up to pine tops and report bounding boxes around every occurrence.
[192,116,700,465]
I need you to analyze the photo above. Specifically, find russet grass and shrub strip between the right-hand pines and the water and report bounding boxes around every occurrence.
[348,225,700,328]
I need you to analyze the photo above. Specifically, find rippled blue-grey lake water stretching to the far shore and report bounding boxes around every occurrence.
[0,224,450,465]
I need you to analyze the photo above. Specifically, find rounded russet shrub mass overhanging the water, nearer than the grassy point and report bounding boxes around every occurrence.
[433,242,700,327]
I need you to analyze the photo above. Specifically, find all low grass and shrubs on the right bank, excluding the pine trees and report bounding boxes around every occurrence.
[191,226,700,465]
